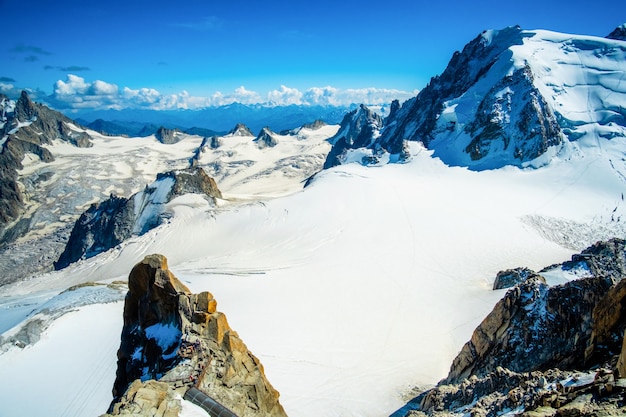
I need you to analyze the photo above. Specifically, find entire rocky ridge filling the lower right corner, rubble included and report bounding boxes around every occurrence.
[393,239,626,417]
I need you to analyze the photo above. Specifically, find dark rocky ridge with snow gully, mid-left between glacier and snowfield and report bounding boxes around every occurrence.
[54,167,222,270]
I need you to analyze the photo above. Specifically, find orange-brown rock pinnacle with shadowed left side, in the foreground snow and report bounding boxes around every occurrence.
[108,255,285,417]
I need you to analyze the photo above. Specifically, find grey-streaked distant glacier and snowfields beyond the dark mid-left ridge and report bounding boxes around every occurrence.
[0,121,338,283]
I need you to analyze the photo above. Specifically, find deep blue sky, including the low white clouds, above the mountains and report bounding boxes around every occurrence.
[0,0,626,108]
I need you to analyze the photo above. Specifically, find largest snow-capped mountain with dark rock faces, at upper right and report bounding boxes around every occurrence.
[326,27,626,170]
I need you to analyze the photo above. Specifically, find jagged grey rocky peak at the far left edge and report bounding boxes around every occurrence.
[0,91,92,242]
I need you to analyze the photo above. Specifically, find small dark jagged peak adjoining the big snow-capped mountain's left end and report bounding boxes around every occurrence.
[324,104,383,169]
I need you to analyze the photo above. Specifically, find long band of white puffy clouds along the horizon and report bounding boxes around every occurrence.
[47,74,417,110]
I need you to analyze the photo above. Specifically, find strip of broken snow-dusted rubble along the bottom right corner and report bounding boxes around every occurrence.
[391,368,626,417]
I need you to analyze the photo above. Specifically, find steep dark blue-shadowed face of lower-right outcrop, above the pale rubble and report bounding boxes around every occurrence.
[446,275,613,383]
